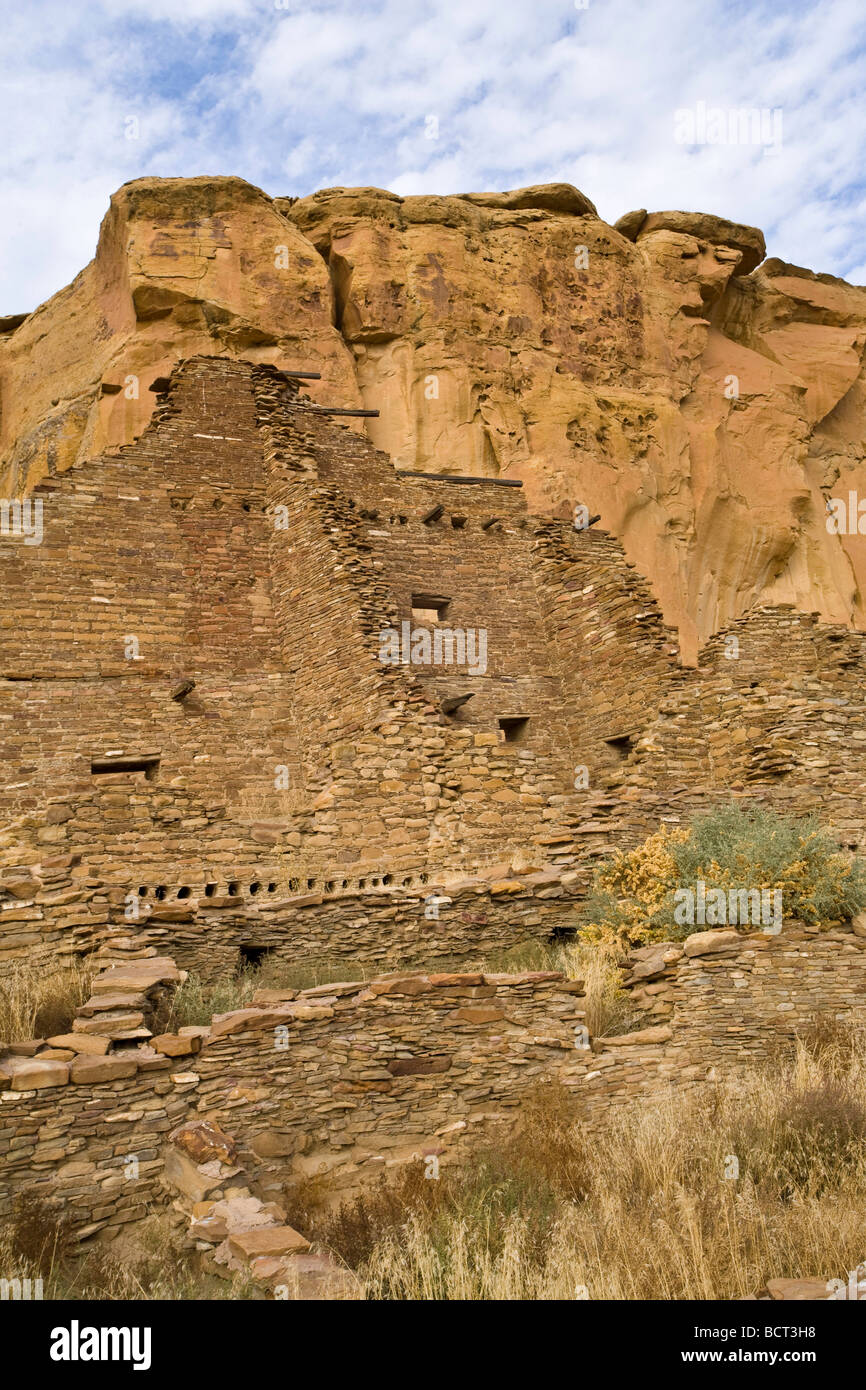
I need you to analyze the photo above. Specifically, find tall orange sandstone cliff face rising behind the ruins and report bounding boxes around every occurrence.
[0,178,866,659]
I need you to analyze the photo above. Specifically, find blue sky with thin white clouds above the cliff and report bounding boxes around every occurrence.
[0,0,866,316]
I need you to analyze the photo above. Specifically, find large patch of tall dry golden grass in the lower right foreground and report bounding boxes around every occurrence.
[287,1030,866,1300]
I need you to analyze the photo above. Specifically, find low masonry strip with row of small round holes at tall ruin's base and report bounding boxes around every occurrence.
[0,853,581,980]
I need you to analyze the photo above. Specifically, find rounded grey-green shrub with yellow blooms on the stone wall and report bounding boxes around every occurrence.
[578,805,866,945]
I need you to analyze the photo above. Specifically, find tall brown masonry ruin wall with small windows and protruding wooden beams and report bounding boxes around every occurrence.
[0,359,671,973]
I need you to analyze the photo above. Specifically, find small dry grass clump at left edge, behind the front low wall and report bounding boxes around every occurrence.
[0,956,93,1043]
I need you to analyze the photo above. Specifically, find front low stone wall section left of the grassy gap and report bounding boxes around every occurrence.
[0,973,584,1234]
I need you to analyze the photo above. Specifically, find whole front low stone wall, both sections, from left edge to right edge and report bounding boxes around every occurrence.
[6,923,866,1234]
